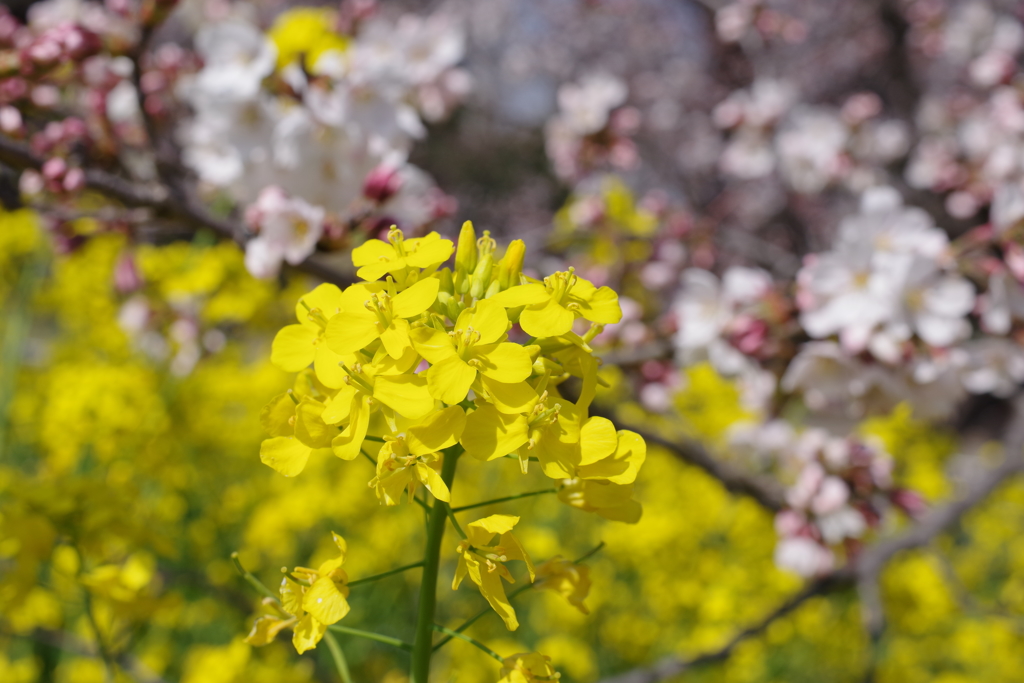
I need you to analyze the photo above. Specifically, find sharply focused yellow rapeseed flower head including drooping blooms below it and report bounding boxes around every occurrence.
[258,222,646,671]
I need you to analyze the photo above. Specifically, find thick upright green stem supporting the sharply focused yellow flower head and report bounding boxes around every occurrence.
[410,444,462,683]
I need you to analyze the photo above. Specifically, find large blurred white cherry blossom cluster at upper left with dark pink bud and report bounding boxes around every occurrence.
[178,7,469,276]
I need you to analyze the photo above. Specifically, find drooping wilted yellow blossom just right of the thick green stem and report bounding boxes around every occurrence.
[452,515,536,631]
